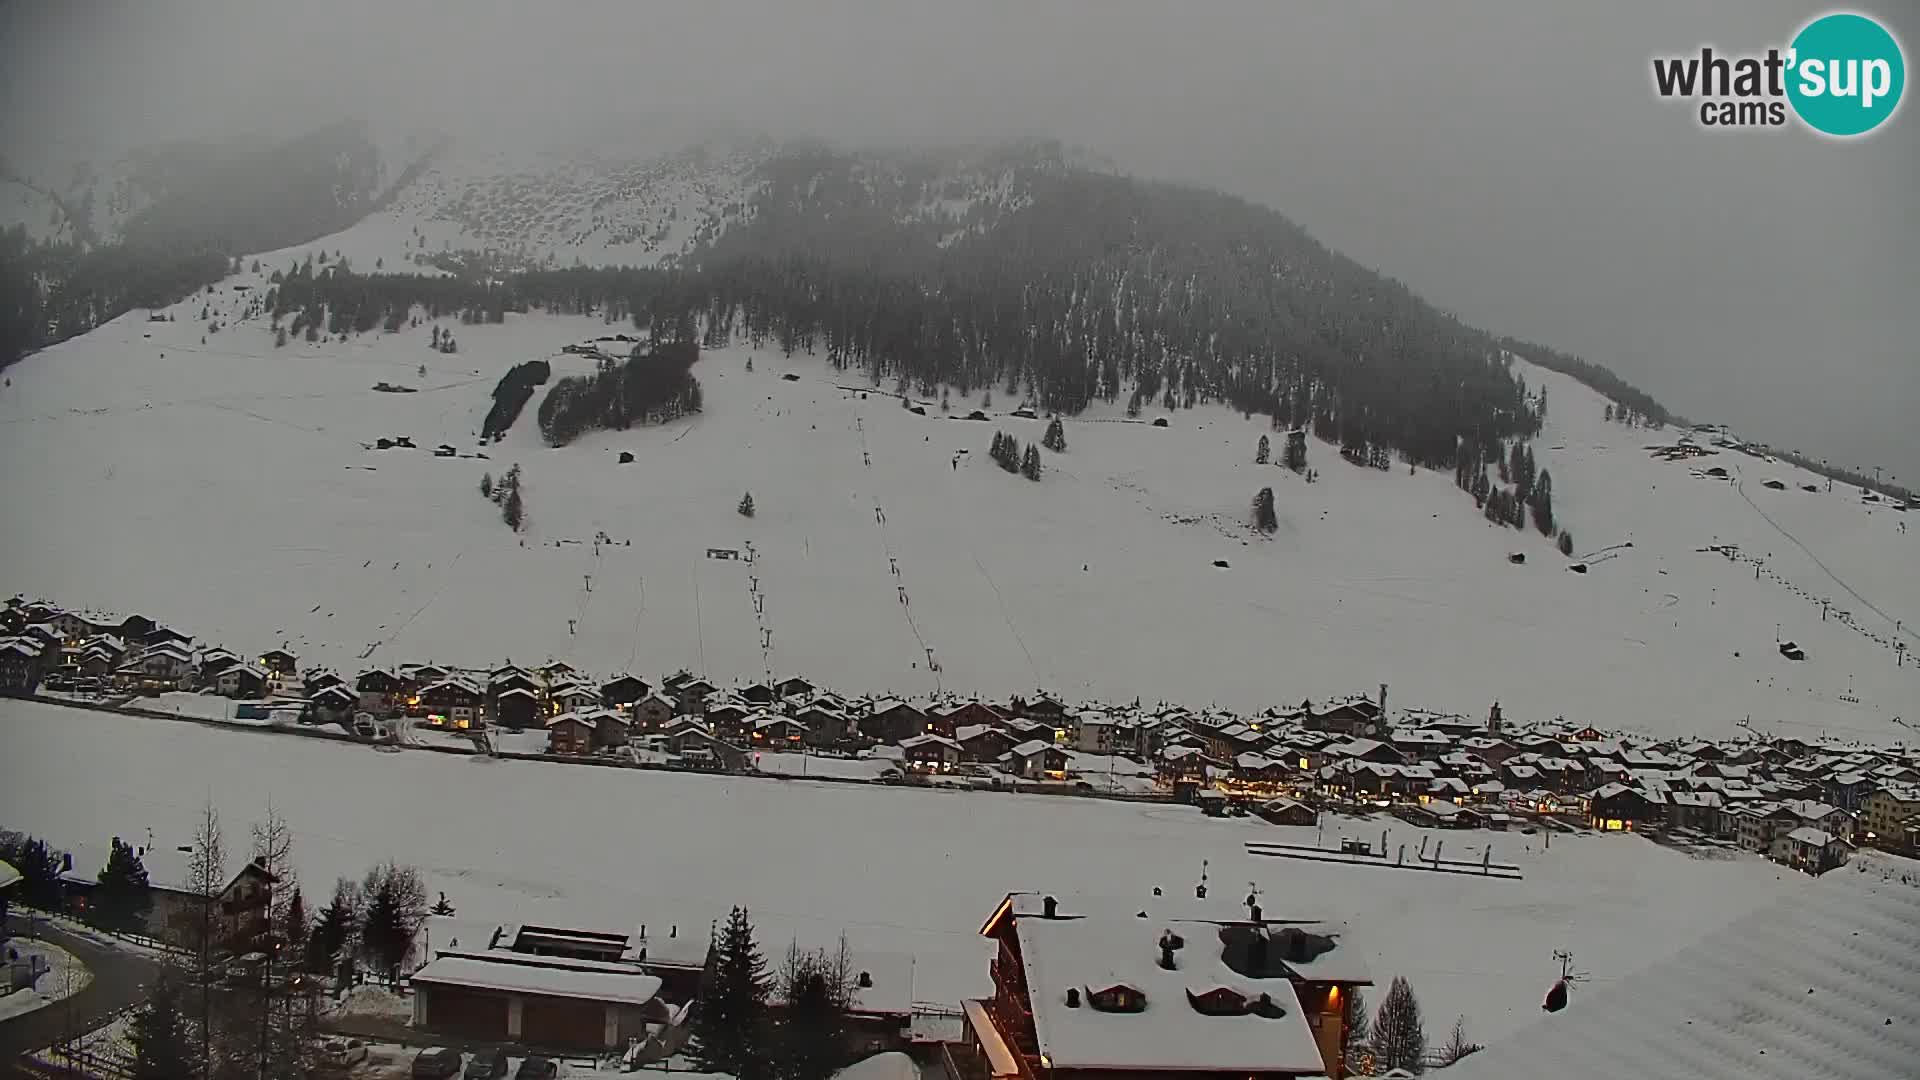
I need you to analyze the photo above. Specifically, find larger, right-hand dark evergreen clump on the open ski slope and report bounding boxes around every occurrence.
[540,340,701,446]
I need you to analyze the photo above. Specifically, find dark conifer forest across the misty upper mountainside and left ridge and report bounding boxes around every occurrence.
[0,129,1665,467]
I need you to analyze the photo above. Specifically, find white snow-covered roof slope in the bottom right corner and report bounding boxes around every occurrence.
[1448,855,1920,1080]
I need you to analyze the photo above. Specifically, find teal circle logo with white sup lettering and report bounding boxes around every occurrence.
[1788,12,1907,136]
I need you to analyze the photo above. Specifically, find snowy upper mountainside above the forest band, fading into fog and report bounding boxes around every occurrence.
[249,138,1112,269]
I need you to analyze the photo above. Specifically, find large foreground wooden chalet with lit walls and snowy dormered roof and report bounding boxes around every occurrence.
[956,894,1373,1080]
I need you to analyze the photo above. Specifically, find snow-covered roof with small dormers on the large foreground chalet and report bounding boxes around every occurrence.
[1020,919,1323,1072]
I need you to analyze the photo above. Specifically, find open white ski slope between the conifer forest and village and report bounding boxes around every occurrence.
[0,259,1920,740]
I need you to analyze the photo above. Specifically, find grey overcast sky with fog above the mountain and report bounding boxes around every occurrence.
[0,0,1920,482]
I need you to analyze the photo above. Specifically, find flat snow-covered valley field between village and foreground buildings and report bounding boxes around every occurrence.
[0,701,1809,1042]
